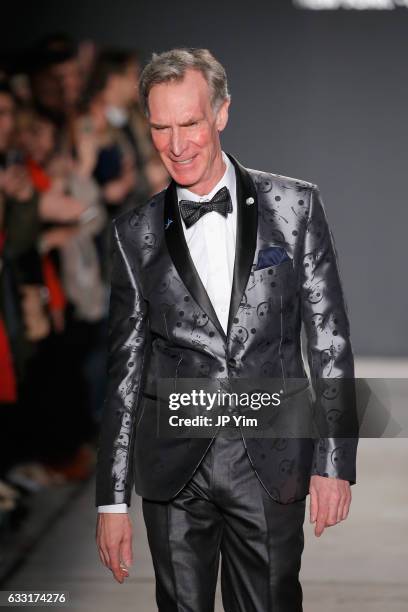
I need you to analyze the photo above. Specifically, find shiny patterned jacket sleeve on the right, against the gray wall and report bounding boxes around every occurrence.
[301,185,358,484]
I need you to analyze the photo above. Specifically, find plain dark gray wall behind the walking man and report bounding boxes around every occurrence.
[0,0,408,356]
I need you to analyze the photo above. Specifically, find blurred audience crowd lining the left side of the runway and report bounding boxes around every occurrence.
[0,34,168,537]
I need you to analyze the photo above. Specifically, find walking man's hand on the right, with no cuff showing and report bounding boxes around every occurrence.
[309,475,351,537]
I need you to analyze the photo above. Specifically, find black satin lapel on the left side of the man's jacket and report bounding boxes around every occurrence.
[164,181,226,340]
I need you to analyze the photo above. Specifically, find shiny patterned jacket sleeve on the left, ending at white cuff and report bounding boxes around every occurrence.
[95,221,149,506]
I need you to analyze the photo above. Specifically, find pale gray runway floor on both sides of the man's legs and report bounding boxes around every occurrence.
[3,360,408,612]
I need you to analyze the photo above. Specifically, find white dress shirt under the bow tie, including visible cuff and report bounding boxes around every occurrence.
[98,151,237,512]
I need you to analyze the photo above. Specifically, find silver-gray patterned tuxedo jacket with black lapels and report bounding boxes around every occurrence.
[95,155,357,506]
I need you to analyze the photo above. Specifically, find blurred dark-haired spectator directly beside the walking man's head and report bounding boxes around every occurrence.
[83,49,168,215]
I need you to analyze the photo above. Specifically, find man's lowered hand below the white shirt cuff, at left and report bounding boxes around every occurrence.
[96,512,133,583]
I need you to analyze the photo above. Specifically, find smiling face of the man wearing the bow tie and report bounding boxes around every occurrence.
[148,70,229,194]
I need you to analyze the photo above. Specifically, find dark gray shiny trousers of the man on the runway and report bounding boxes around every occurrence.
[143,432,306,612]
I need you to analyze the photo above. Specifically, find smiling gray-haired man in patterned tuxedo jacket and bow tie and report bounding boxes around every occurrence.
[96,49,357,612]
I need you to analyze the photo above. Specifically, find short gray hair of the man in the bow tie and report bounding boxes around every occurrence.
[139,48,231,117]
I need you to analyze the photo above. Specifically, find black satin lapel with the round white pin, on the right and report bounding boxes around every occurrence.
[227,153,258,334]
